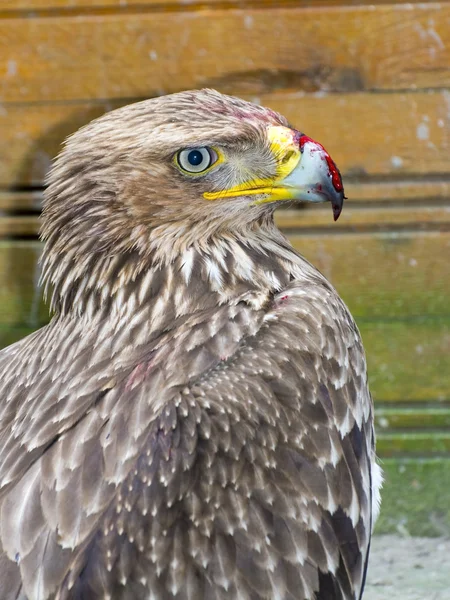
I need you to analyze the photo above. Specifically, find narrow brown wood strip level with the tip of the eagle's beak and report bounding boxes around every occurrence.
[0,204,450,237]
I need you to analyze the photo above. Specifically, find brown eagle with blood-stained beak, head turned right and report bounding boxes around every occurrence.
[0,90,382,600]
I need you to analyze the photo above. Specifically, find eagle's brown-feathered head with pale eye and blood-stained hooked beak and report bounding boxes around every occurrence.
[41,90,344,312]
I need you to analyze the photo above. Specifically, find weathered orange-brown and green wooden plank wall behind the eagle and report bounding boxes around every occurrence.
[0,0,450,533]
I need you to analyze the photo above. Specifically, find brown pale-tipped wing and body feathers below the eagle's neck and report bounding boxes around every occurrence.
[0,282,373,600]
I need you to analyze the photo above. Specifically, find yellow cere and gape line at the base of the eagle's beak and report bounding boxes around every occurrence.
[203,126,301,204]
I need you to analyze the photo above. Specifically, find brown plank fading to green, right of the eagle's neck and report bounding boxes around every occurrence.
[289,232,450,322]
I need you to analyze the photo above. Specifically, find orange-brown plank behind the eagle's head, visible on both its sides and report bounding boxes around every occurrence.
[0,91,450,185]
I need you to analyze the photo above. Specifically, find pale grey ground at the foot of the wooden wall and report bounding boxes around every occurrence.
[363,535,450,600]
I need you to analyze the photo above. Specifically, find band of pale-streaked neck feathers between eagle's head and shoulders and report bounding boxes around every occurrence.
[42,223,311,329]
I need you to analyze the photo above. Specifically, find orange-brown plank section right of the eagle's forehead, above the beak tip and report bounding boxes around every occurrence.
[263,91,450,177]
